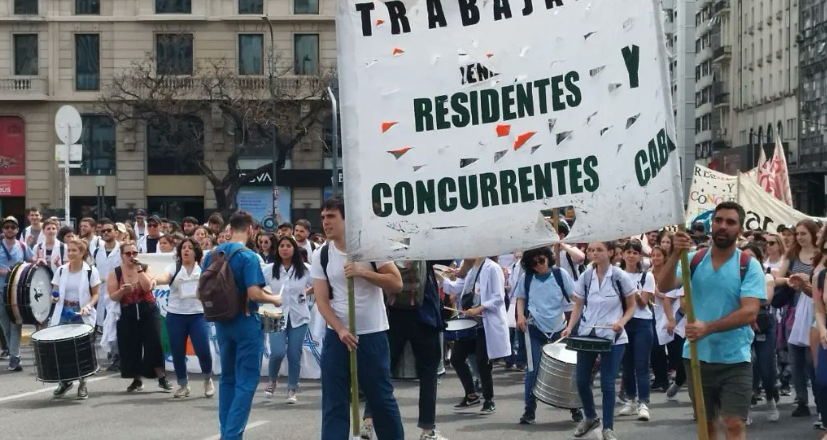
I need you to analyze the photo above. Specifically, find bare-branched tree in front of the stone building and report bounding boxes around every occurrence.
[99,46,335,215]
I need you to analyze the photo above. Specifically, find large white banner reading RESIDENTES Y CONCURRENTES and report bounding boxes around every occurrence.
[336,0,684,261]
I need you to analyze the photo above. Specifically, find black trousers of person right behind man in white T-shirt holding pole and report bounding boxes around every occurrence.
[365,310,442,429]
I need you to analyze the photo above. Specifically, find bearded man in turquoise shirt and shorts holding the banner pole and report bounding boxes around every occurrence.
[657,202,767,440]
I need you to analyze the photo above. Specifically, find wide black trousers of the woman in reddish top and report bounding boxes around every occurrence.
[117,302,164,379]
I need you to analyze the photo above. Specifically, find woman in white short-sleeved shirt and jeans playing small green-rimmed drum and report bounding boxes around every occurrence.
[560,242,632,440]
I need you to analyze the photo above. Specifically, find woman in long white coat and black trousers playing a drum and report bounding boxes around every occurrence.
[451,258,511,414]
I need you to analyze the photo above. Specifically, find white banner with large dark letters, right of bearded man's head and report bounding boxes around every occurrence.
[738,174,818,232]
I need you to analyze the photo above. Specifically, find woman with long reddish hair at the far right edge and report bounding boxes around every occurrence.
[775,219,819,417]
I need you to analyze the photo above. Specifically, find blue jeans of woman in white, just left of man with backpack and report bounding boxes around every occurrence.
[166,313,212,386]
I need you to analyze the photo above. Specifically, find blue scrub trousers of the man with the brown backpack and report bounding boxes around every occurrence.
[215,313,264,440]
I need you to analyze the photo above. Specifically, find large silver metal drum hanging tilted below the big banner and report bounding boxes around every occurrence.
[532,343,583,409]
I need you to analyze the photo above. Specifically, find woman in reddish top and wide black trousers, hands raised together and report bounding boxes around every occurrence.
[106,242,172,393]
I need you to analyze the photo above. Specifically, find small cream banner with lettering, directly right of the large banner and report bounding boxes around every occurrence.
[686,164,738,221]
